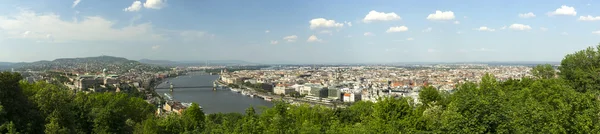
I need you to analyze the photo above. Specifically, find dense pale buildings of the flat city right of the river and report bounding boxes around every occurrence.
[220,64,531,102]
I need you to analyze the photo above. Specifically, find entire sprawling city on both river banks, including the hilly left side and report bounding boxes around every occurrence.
[4,56,548,114]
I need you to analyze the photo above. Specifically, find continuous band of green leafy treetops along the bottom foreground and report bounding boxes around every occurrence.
[0,44,600,134]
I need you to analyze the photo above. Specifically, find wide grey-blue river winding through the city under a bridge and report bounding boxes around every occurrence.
[156,73,273,114]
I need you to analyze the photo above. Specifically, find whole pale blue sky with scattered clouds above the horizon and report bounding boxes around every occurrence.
[0,0,600,63]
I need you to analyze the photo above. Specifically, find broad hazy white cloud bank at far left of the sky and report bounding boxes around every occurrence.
[0,10,167,42]
